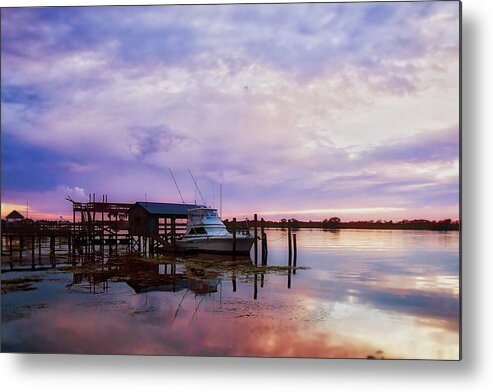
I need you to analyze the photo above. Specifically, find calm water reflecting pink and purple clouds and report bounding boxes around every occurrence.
[2,230,460,359]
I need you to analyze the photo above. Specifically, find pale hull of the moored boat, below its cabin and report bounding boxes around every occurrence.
[176,237,254,255]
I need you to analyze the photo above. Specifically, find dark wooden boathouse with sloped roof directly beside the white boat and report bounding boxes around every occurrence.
[128,201,203,237]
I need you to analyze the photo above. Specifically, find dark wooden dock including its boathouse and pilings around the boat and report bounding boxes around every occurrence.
[1,194,297,265]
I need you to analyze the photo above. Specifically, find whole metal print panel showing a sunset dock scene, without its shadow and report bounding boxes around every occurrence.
[1,1,461,360]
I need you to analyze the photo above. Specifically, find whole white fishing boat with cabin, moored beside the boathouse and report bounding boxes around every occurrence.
[176,207,255,254]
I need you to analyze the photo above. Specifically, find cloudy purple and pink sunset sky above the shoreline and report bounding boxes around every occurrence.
[1,1,459,220]
